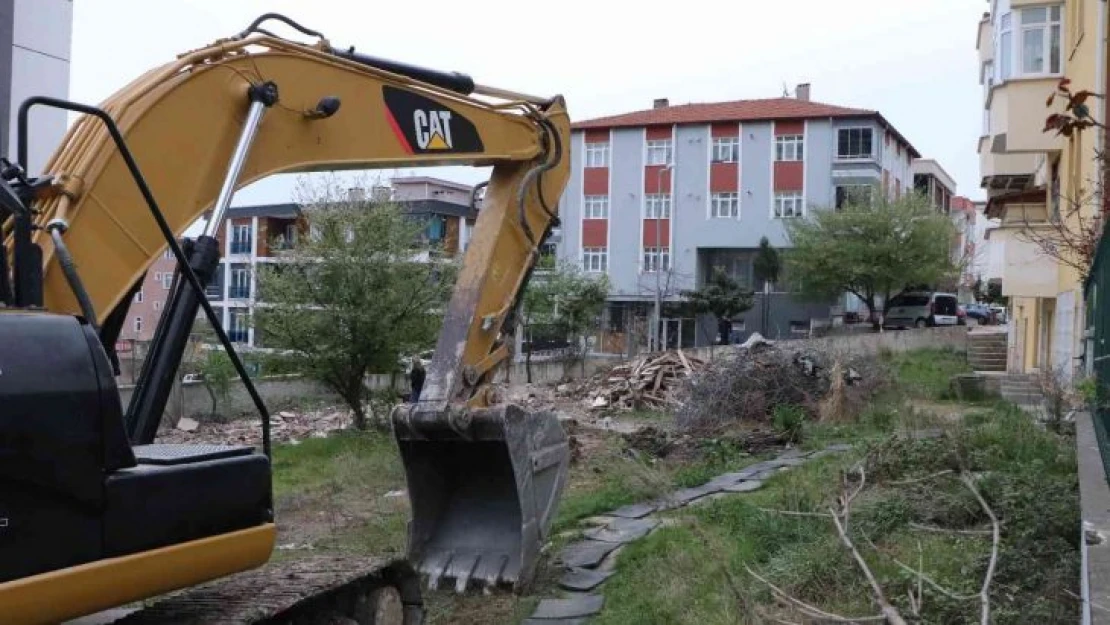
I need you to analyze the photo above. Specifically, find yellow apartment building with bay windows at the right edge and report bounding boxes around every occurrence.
[977,0,1108,375]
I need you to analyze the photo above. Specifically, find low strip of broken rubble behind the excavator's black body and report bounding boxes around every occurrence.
[158,406,354,445]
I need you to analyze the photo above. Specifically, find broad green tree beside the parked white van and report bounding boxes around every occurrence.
[784,194,959,330]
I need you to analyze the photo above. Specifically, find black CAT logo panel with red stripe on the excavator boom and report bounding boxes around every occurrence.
[382,85,485,154]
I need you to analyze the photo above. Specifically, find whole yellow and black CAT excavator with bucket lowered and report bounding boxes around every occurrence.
[0,13,569,625]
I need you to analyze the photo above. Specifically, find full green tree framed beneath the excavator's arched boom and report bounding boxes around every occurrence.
[253,182,455,429]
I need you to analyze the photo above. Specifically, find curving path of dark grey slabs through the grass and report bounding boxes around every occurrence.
[524,444,851,625]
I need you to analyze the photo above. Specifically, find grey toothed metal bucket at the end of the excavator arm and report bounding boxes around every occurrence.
[393,404,571,593]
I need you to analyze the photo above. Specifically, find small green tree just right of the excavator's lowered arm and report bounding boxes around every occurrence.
[521,260,609,382]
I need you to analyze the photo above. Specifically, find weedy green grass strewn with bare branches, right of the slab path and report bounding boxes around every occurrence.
[596,395,1079,625]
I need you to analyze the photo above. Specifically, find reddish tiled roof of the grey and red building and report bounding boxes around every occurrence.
[571,98,921,159]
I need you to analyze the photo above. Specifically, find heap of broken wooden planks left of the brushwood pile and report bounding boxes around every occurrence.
[585,351,705,411]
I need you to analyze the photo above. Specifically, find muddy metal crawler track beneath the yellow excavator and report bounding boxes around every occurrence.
[97,556,424,625]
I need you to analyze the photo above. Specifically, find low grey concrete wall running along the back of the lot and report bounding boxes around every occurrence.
[127,327,968,423]
